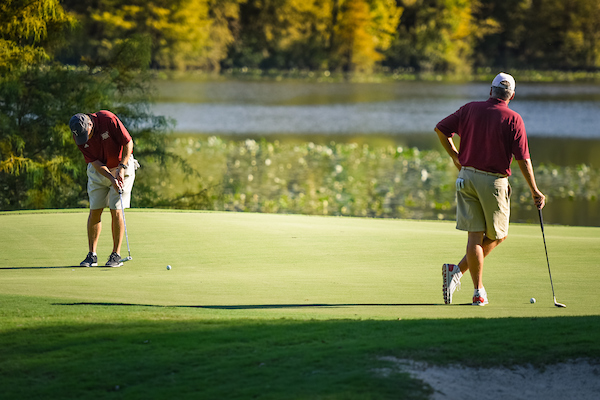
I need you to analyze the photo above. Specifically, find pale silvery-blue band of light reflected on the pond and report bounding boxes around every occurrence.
[154,98,600,138]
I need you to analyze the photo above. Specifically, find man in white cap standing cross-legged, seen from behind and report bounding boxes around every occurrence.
[435,73,545,306]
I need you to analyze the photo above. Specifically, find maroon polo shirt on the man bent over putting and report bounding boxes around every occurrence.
[77,110,131,169]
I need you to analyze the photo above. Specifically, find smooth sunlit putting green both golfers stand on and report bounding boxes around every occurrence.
[0,209,600,319]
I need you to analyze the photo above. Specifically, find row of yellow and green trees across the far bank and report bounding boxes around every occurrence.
[54,0,600,73]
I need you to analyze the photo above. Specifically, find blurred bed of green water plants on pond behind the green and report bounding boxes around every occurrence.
[145,137,600,220]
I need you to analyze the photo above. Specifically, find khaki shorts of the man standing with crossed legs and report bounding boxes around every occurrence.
[456,169,511,240]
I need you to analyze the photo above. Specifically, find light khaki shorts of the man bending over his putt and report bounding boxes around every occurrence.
[87,157,137,210]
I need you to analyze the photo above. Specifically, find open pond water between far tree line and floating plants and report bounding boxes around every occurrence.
[153,81,600,226]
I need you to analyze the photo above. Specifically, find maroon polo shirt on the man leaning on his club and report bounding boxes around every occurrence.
[436,98,530,175]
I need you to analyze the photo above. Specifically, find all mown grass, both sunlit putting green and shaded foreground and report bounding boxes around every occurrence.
[0,209,600,399]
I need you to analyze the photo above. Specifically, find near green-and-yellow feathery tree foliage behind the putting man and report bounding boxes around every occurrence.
[0,1,185,210]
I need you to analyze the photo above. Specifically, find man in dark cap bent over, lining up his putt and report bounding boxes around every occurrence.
[69,111,139,267]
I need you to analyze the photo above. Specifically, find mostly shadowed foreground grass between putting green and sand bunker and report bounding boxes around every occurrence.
[0,290,600,399]
